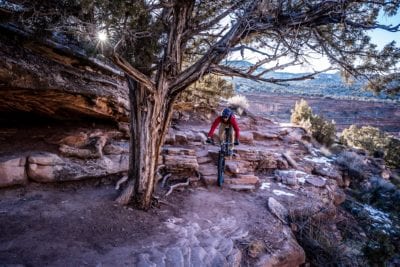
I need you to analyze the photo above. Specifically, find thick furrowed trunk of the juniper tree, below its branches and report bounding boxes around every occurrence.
[117,77,172,210]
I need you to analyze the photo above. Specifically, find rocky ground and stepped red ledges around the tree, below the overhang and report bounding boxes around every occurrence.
[0,109,400,266]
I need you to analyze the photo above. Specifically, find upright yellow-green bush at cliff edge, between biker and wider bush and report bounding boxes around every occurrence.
[290,99,336,146]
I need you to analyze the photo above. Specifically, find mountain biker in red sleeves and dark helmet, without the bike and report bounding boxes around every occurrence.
[206,108,240,154]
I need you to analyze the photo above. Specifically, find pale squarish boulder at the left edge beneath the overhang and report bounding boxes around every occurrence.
[0,156,28,187]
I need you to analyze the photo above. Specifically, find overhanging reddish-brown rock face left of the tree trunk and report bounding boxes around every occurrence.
[0,24,129,121]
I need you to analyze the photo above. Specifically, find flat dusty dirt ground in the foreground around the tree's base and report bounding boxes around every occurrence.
[0,180,281,266]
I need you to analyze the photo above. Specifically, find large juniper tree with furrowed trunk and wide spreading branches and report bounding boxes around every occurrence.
[2,0,400,209]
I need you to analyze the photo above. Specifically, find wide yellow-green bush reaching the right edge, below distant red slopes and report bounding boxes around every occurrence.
[340,125,400,168]
